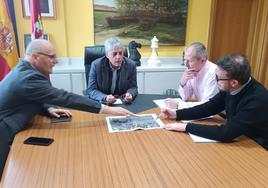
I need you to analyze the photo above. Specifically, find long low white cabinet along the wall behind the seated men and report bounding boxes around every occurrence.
[50,59,185,95]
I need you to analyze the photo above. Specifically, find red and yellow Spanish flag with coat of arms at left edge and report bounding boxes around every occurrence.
[0,0,19,81]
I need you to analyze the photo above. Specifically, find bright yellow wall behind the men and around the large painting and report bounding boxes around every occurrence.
[15,0,212,57]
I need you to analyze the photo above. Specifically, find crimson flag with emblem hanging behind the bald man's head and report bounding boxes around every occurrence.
[30,0,43,40]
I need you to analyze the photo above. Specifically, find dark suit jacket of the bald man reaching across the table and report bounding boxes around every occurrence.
[0,61,101,134]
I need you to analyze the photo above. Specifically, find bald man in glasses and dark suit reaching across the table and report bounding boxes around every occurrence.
[0,39,132,178]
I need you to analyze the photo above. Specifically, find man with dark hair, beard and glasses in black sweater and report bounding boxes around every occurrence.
[160,55,268,149]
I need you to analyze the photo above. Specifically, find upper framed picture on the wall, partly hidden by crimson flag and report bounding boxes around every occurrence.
[21,0,56,19]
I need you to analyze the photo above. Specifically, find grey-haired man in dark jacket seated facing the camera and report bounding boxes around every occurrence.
[88,38,138,104]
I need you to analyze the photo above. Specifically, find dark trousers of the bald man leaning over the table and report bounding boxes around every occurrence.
[0,121,14,179]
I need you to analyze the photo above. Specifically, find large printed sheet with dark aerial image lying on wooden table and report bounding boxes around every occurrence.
[106,114,164,132]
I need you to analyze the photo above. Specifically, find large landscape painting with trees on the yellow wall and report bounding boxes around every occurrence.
[93,0,188,46]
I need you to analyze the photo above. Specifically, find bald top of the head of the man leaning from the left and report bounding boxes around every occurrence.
[25,39,54,56]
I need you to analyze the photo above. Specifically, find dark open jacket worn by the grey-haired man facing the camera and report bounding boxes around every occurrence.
[88,57,138,102]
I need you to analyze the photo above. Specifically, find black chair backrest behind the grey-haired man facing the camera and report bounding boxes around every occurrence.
[84,45,128,85]
